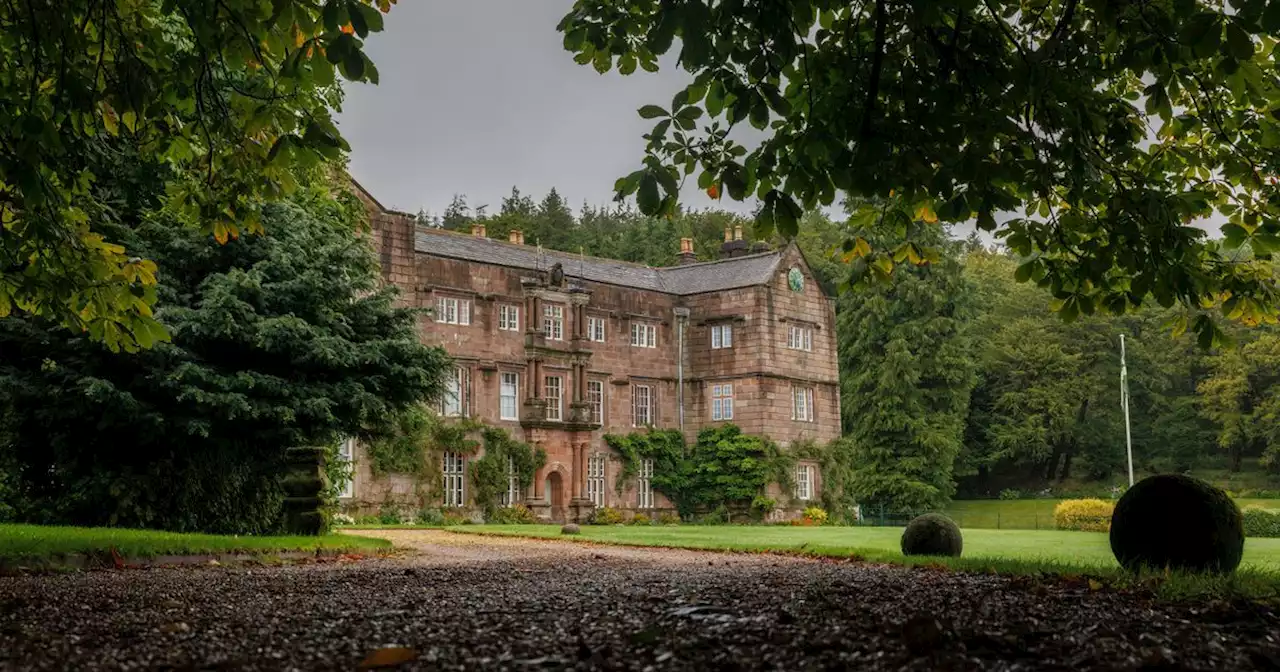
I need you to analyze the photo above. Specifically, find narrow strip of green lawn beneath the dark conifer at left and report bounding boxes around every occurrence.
[0,524,390,559]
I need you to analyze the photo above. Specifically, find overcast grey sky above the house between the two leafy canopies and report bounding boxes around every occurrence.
[339,0,750,214]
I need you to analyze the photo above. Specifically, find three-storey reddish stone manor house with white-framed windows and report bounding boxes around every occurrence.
[346,187,840,521]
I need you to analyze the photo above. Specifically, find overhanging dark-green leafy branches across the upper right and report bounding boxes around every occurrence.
[559,0,1280,344]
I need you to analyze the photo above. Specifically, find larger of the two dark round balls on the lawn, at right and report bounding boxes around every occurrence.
[1111,474,1244,573]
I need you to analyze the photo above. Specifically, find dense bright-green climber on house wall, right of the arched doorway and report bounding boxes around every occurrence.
[604,424,795,517]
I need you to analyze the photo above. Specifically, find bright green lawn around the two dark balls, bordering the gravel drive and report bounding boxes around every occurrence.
[449,525,1280,600]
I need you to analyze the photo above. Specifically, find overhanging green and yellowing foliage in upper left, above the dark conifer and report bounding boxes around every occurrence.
[0,0,396,349]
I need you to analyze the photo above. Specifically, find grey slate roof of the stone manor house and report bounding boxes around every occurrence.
[413,229,782,294]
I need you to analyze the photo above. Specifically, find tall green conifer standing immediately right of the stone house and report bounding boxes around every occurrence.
[836,222,974,512]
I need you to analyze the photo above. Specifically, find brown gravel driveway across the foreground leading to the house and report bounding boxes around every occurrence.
[0,531,1280,672]
